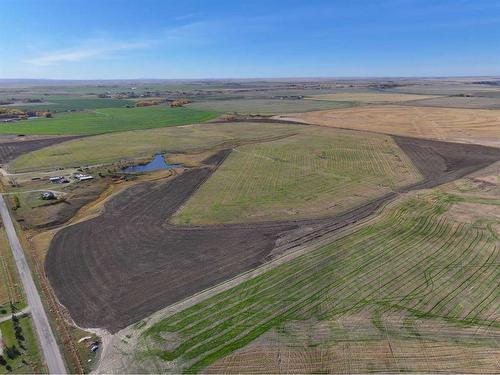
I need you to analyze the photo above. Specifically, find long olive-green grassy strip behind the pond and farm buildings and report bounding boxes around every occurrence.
[10,123,300,171]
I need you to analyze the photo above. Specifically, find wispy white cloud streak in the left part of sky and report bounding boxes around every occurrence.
[24,40,153,66]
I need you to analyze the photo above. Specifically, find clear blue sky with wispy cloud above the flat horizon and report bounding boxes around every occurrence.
[0,0,500,79]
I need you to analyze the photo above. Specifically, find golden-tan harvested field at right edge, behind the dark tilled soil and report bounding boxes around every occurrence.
[288,106,500,147]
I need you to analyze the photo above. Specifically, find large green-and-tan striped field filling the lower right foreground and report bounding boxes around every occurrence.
[135,190,500,373]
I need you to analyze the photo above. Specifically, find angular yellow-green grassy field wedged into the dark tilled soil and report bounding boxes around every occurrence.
[175,127,421,224]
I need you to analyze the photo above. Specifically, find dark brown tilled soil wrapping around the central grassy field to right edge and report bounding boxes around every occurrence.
[45,137,500,332]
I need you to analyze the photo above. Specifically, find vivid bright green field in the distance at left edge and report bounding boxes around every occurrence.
[0,106,217,135]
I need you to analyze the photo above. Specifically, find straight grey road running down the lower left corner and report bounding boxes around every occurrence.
[0,195,66,374]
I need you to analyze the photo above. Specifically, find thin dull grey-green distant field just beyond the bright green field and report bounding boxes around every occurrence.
[188,99,352,115]
